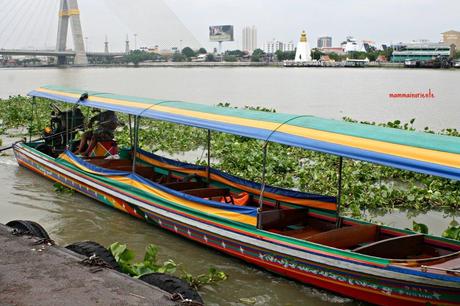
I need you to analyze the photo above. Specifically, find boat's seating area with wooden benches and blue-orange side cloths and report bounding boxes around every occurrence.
[54,150,460,266]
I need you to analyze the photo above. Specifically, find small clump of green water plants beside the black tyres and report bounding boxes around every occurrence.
[109,242,228,289]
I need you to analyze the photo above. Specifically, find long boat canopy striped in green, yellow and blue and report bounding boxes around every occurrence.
[29,85,460,180]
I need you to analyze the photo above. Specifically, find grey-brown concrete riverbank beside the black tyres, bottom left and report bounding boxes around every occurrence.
[0,224,177,305]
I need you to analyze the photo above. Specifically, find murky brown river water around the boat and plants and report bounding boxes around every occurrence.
[0,68,460,305]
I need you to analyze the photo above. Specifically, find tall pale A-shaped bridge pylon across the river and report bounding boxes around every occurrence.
[56,0,88,66]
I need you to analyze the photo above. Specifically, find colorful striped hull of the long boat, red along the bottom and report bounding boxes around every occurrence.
[14,144,460,305]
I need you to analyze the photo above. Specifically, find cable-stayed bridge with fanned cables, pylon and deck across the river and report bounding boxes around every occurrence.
[0,0,200,65]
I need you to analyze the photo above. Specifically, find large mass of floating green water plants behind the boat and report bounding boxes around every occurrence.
[0,96,460,218]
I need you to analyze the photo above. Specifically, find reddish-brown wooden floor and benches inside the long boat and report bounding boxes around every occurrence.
[88,159,455,260]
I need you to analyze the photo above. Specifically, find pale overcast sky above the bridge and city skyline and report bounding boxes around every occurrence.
[0,0,460,51]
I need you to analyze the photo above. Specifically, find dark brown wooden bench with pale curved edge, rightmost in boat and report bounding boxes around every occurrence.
[353,234,425,259]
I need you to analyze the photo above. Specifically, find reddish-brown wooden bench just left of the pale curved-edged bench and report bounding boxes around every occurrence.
[305,224,378,249]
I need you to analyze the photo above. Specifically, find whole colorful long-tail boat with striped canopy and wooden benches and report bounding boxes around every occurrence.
[14,86,460,306]
